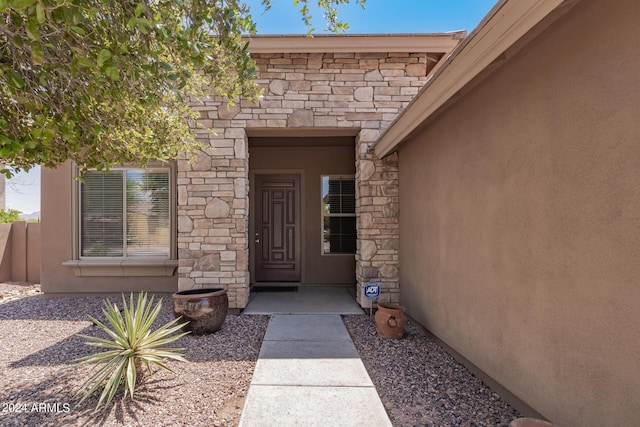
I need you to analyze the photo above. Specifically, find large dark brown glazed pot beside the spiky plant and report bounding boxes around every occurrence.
[173,288,229,335]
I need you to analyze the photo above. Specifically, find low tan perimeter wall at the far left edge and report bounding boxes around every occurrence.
[0,221,40,283]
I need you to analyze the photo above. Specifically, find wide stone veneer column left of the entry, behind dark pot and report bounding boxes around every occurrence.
[178,122,249,308]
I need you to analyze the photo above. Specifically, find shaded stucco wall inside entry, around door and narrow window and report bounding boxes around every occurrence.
[249,138,356,285]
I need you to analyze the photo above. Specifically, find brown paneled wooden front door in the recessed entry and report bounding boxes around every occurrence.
[254,175,300,282]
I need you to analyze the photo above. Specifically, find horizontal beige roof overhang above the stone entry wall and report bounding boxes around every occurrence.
[246,31,466,54]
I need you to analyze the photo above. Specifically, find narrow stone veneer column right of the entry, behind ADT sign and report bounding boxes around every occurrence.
[356,130,400,307]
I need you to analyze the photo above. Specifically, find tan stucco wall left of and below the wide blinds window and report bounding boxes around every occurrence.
[40,162,178,294]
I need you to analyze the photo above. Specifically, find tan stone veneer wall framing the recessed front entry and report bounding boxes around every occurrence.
[178,46,434,308]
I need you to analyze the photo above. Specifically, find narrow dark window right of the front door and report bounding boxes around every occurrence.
[322,176,356,255]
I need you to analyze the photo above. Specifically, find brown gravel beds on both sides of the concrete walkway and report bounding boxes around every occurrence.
[0,283,519,426]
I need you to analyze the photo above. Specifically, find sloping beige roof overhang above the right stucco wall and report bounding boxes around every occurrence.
[375,0,575,157]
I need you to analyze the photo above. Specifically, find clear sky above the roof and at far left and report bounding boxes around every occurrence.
[6,0,496,214]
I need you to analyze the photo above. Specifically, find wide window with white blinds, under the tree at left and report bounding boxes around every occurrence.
[80,168,171,258]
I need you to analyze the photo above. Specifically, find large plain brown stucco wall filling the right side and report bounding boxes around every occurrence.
[399,0,640,426]
